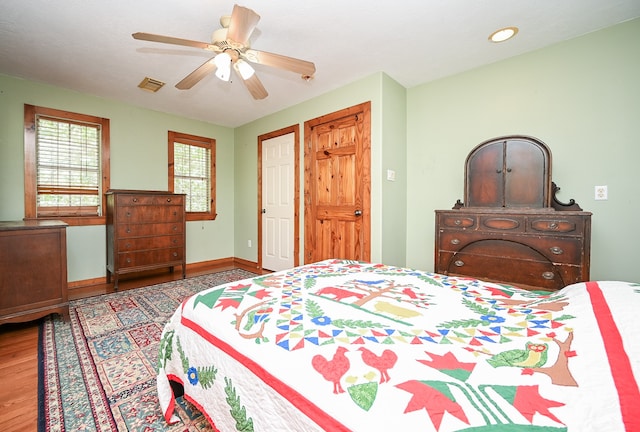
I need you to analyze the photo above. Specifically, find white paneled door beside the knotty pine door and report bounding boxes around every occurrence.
[262,133,295,271]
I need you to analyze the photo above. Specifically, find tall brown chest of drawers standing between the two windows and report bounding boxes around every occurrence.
[106,190,186,290]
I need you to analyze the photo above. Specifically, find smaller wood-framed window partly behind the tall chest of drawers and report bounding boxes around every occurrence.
[169,131,216,220]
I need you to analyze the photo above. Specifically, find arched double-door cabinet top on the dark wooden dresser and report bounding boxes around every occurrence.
[465,135,551,208]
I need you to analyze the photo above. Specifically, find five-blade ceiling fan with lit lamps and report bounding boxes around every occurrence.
[132,5,316,99]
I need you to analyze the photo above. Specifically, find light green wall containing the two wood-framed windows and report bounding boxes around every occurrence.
[0,75,234,281]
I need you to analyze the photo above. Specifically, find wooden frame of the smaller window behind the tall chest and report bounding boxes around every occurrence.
[167,131,218,221]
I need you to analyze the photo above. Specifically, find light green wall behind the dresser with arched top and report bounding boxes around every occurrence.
[407,20,640,282]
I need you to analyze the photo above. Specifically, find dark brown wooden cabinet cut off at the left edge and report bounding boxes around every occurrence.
[0,220,69,324]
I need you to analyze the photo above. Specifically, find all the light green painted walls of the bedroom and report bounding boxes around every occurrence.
[0,16,640,282]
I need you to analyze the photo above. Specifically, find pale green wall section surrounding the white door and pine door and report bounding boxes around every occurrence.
[235,73,406,264]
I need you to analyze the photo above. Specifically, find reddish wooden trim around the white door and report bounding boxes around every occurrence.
[257,124,300,270]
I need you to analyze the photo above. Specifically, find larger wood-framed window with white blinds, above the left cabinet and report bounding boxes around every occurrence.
[24,104,110,225]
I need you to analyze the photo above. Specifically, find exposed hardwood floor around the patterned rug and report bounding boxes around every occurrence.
[0,266,239,432]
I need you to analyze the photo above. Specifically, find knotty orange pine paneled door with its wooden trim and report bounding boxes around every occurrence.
[304,102,371,263]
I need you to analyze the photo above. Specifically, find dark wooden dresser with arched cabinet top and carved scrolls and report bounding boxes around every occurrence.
[435,135,591,291]
